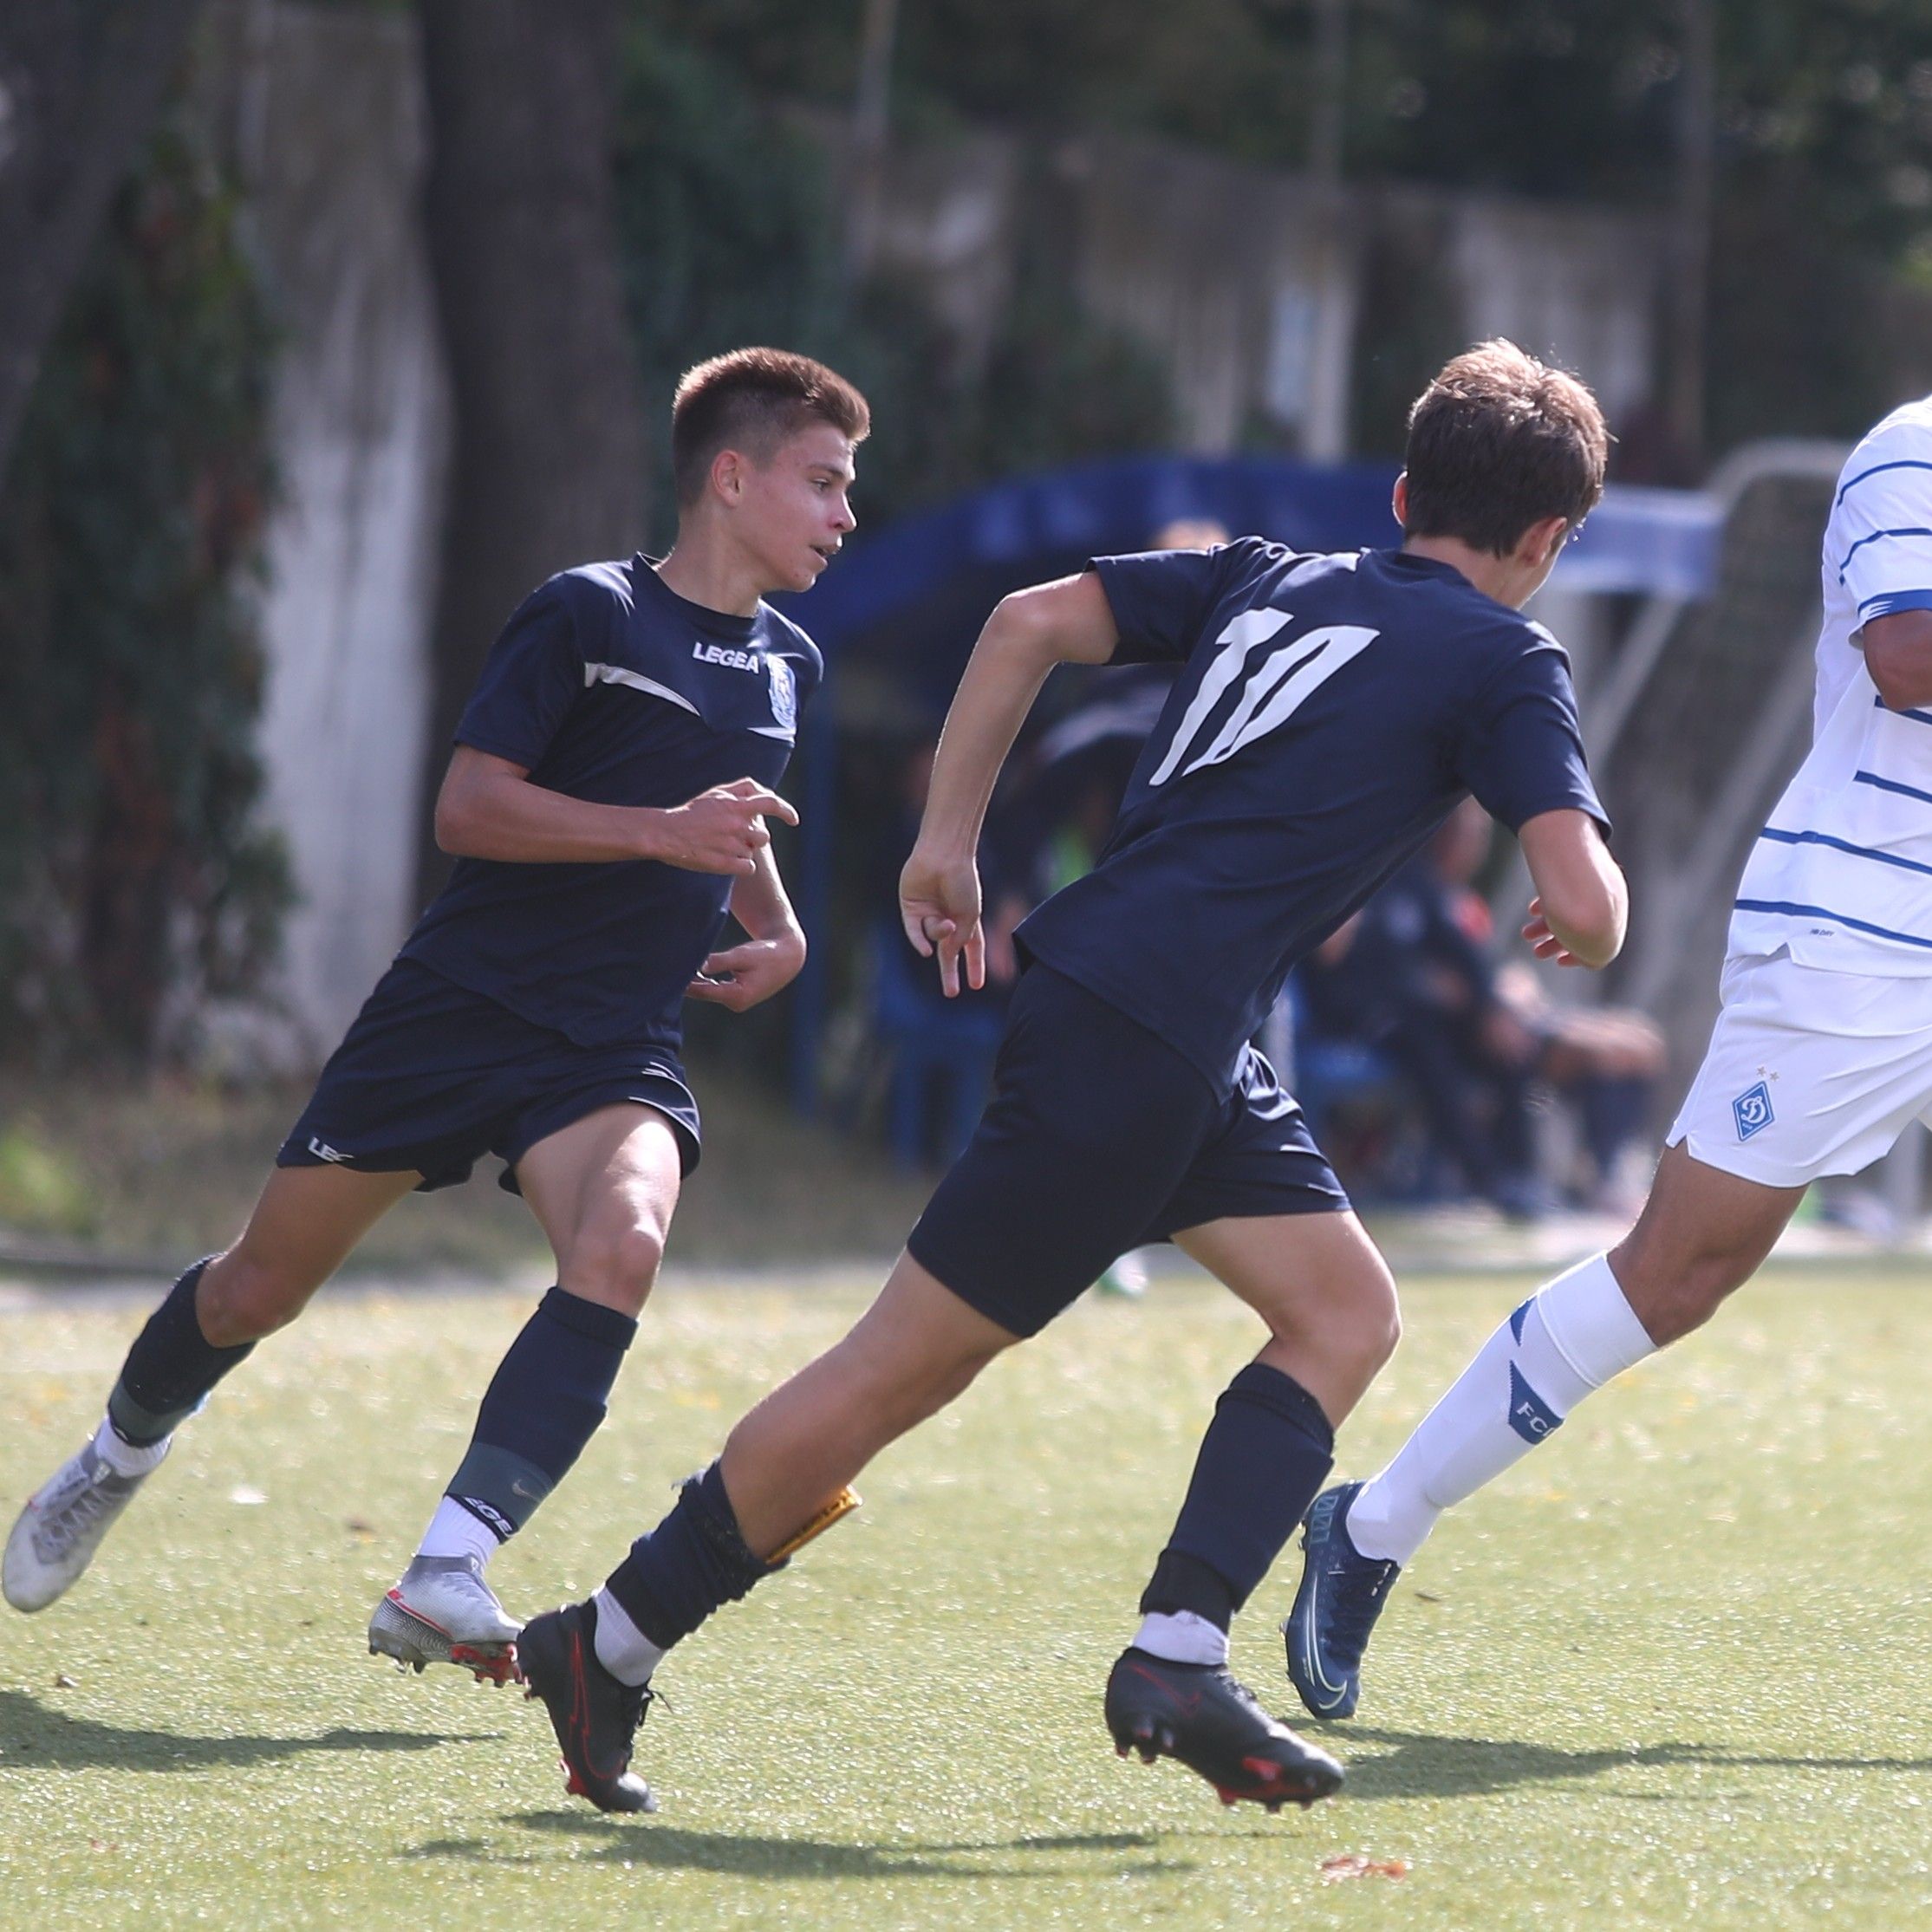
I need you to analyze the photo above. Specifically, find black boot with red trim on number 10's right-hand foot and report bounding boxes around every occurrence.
[1107,1650,1343,1812]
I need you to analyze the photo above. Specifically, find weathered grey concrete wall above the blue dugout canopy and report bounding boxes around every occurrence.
[854,121,1665,460]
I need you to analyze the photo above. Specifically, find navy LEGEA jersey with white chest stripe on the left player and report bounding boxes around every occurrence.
[402,556,823,1047]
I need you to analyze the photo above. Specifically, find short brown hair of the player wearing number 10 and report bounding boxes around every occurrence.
[1402,338,1610,556]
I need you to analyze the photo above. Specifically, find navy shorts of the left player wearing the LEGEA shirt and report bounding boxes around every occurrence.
[275,959,699,1194]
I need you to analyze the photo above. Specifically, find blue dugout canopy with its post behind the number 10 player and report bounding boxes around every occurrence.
[783,444,1723,1111]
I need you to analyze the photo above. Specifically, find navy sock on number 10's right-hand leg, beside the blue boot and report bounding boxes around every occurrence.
[1140,1362,1335,1630]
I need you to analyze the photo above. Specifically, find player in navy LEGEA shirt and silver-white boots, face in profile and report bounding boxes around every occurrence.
[0,348,869,1681]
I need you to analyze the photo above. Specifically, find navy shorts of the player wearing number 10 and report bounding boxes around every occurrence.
[906,964,1349,1335]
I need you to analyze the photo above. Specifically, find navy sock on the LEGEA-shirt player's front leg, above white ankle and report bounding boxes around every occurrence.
[445,1289,638,1542]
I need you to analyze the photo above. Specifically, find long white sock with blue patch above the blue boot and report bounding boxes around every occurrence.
[1347,1254,1656,1563]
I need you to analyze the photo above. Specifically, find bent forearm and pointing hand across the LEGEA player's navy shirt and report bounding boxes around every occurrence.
[437,744,798,875]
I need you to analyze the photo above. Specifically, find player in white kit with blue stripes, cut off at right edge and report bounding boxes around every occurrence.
[1285,396,1932,1718]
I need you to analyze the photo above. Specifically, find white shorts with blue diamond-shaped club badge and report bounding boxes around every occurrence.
[1665,953,1932,1188]
